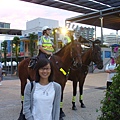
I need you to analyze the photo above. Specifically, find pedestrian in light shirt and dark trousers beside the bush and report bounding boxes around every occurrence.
[105,56,117,90]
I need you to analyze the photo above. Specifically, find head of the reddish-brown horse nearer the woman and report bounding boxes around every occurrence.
[70,40,82,67]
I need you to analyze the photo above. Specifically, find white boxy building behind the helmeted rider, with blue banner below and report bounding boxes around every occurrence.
[20,18,59,57]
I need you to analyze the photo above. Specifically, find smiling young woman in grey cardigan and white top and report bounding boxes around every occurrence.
[23,58,61,120]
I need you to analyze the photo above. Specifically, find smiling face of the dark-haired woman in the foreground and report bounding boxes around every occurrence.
[39,64,51,79]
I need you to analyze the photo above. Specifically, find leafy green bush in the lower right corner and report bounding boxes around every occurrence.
[98,61,120,120]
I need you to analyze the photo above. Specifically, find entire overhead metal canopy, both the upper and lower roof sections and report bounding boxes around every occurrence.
[21,0,120,30]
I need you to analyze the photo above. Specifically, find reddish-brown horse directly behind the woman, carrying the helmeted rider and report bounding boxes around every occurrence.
[18,41,82,118]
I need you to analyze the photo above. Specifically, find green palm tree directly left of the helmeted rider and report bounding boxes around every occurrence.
[29,33,38,57]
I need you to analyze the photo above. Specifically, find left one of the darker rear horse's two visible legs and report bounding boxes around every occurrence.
[72,80,77,110]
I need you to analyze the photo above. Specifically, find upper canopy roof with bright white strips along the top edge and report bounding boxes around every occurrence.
[21,0,120,14]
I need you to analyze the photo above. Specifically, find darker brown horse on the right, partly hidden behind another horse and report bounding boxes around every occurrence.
[69,40,103,110]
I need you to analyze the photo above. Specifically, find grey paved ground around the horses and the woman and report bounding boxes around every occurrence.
[0,73,107,120]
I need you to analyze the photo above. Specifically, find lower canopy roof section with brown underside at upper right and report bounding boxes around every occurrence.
[66,7,120,30]
